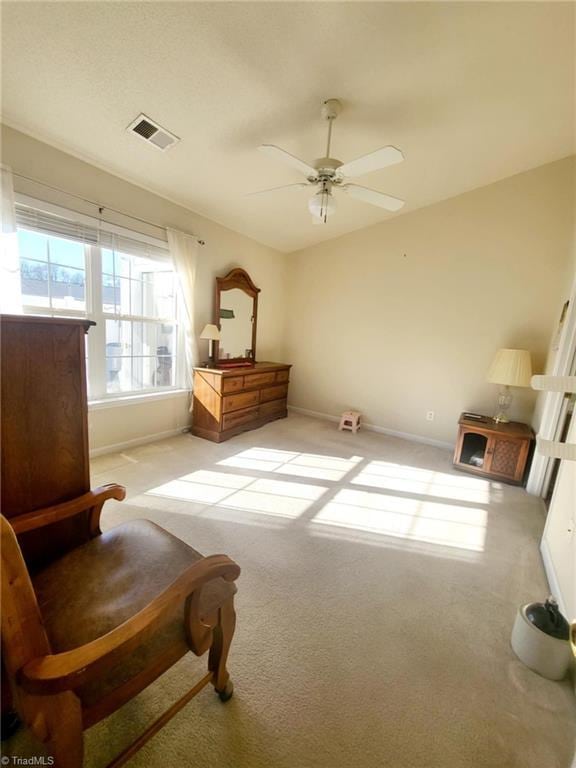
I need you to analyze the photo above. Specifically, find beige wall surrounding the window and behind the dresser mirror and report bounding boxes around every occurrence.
[2,126,287,450]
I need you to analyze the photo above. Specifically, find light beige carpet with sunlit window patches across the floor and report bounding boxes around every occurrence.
[7,415,576,768]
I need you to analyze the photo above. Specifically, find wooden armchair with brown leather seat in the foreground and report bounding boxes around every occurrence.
[1,485,240,768]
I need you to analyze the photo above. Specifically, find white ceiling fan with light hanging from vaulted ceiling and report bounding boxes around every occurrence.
[249,99,404,224]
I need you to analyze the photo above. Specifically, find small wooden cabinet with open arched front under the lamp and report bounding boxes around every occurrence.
[454,413,534,484]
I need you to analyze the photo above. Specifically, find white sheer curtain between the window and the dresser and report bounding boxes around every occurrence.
[167,229,199,386]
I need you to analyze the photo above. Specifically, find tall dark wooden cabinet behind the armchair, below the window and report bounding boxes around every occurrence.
[0,315,94,567]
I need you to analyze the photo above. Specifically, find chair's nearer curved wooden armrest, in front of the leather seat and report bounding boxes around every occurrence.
[17,555,240,694]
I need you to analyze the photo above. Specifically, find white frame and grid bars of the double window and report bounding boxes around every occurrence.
[16,194,187,407]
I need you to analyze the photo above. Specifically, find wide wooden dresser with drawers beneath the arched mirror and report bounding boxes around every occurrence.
[192,363,291,443]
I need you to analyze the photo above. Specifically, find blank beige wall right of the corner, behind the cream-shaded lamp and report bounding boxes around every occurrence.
[286,158,575,443]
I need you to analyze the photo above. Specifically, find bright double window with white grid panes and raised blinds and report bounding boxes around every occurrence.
[17,205,183,400]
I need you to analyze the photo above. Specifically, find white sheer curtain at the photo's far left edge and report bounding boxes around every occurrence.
[0,165,22,314]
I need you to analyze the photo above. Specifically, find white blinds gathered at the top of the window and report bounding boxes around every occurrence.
[16,203,170,261]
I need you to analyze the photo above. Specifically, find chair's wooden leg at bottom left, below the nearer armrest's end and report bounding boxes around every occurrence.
[27,693,84,768]
